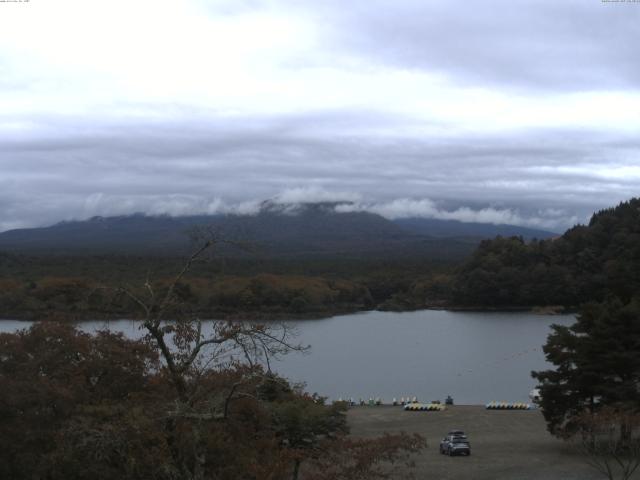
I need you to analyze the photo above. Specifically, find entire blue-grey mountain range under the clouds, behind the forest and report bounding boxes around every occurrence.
[0,202,550,258]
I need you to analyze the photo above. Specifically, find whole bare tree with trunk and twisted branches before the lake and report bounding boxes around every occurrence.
[118,232,308,480]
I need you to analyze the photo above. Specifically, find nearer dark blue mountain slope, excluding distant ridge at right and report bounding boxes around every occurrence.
[0,206,414,255]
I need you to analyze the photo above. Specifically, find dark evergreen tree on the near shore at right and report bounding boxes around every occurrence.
[532,298,640,435]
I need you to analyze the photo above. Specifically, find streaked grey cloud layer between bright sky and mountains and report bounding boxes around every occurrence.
[0,112,640,229]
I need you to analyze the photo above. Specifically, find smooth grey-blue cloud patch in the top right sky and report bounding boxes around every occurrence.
[304,0,640,90]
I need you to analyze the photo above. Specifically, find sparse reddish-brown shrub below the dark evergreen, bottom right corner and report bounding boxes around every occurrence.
[574,407,640,480]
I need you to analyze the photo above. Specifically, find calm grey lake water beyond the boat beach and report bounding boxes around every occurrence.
[0,310,574,404]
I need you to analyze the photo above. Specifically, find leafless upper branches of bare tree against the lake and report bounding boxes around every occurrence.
[119,234,308,404]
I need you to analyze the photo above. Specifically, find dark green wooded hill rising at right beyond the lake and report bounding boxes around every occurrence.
[453,198,640,307]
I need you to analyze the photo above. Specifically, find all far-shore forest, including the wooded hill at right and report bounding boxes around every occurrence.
[0,198,640,320]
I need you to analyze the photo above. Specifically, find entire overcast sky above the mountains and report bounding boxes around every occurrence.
[0,0,640,231]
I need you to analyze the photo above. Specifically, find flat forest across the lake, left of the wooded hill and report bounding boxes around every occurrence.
[0,254,452,319]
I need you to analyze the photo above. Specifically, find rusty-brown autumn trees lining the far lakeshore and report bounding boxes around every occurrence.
[0,274,374,319]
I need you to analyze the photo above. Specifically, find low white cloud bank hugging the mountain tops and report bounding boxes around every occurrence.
[0,186,586,231]
